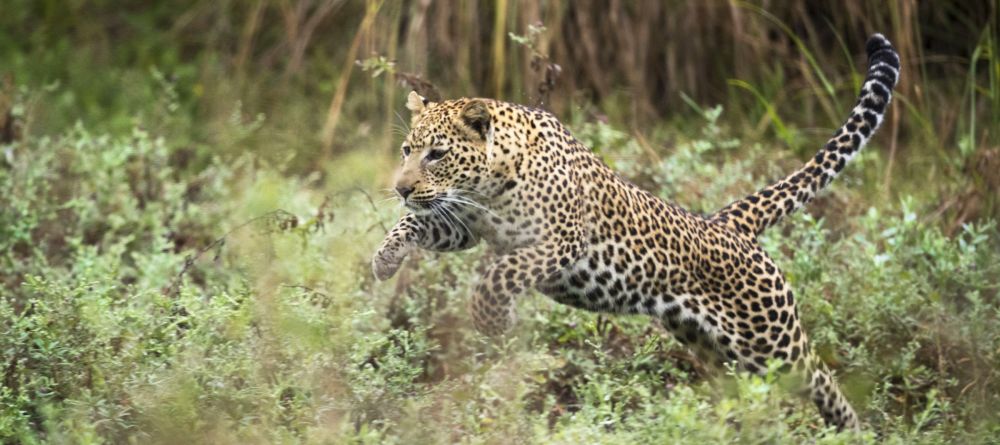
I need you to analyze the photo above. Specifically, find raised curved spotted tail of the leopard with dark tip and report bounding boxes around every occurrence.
[712,34,899,236]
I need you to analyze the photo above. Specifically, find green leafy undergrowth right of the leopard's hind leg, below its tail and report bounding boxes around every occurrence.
[767,206,1000,437]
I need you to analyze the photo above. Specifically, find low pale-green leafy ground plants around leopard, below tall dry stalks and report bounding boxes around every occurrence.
[0,87,1000,443]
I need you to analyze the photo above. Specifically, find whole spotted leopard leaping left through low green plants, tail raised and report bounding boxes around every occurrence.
[372,34,900,431]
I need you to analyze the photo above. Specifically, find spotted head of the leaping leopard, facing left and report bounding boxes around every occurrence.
[395,91,494,214]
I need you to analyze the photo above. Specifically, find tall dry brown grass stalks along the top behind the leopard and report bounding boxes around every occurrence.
[0,0,1000,220]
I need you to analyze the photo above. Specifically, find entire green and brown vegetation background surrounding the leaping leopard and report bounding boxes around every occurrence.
[0,0,1000,443]
